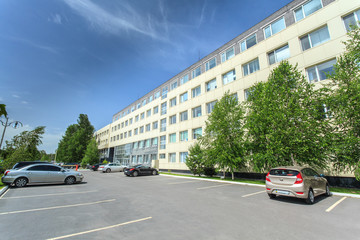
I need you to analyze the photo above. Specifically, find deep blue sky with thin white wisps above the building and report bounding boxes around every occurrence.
[0,0,291,153]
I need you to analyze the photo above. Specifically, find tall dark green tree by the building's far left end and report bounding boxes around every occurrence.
[57,114,95,163]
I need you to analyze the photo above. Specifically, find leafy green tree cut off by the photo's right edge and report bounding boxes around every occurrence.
[329,28,360,180]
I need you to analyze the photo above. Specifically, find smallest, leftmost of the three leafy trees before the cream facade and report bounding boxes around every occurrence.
[200,92,246,179]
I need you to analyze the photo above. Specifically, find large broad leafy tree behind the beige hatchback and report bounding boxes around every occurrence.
[246,61,332,172]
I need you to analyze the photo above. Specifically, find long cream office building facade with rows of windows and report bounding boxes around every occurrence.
[95,0,360,170]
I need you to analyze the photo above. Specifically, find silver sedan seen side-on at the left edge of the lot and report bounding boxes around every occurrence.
[1,163,84,187]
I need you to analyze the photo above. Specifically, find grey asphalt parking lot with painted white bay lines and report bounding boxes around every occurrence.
[0,172,360,240]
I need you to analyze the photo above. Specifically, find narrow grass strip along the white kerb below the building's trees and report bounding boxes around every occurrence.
[161,172,360,194]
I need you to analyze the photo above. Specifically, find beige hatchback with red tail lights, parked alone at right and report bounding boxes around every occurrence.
[266,167,330,204]
